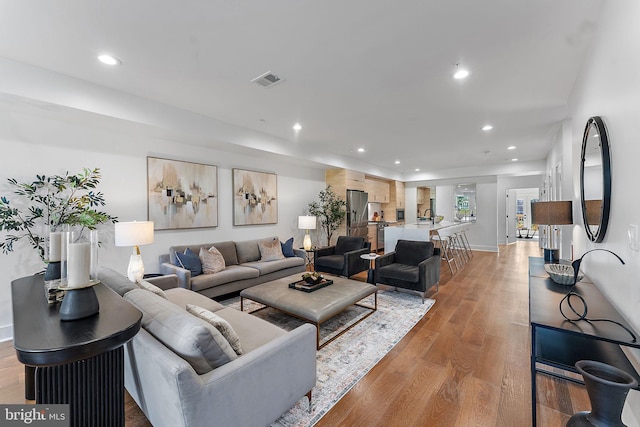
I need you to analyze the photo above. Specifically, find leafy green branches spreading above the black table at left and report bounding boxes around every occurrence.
[0,168,117,261]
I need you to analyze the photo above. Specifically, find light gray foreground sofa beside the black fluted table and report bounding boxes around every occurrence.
[99,267,316,427]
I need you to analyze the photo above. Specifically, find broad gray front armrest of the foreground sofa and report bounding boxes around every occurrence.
[180,324,316,426]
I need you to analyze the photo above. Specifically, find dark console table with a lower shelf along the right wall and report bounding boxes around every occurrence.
[529,257,640,427]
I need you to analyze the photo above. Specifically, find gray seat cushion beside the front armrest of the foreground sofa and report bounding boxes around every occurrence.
[216,307,287,354]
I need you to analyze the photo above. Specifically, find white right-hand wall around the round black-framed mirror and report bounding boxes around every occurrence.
[564,0,640,426]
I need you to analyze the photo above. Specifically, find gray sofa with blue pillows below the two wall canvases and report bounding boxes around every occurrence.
[160,237,306,298]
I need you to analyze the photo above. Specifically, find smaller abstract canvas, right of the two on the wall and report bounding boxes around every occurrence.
[233,169,278,225]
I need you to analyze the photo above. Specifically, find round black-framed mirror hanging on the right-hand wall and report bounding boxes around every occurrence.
[580,116,611,243]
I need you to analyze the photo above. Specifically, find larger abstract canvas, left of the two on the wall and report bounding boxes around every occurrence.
[147,157,218,230]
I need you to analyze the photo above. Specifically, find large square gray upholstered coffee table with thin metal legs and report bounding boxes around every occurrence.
[240,274,378,350]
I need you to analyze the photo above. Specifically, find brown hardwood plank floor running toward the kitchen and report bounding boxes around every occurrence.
[0,241,590,427]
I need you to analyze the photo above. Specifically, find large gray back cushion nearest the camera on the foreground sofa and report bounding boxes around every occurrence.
[124,289,238,374]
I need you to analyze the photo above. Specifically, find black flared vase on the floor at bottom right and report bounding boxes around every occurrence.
[567,360,638,427]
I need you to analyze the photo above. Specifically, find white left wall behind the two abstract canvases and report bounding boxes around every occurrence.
[0,115,325,340]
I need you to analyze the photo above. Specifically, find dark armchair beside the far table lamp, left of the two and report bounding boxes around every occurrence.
[313,236,371,277]
